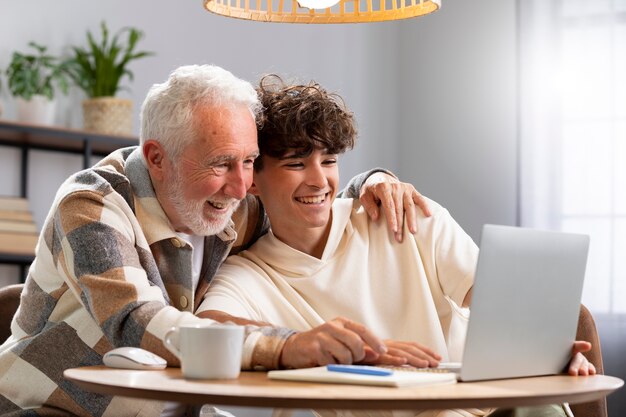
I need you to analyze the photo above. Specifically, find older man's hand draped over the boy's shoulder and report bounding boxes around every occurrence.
[359,172,431,242]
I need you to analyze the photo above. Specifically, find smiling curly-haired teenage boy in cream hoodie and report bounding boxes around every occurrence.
[199,77,595,417]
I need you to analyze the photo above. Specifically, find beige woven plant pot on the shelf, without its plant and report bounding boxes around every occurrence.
[83,97,133,136]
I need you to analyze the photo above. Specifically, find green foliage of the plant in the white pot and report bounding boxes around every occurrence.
[6,42,68,100]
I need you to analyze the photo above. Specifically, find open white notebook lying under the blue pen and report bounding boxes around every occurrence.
[267,366,456,387]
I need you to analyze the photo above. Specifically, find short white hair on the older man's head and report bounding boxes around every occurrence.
[139,65,262,159]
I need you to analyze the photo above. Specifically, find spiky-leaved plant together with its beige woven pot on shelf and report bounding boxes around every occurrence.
[66,22,152,135]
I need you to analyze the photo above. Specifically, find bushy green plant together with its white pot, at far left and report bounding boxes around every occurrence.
[6,42,68,124]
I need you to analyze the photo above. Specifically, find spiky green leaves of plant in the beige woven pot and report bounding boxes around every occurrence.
[66,22,153,98]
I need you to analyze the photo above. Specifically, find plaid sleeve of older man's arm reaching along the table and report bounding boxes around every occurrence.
[50,191,293,368]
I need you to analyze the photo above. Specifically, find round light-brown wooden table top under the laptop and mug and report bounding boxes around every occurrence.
[64,366,624,409]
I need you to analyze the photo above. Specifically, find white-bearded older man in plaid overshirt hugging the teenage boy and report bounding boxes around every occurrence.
[0,66,419,416]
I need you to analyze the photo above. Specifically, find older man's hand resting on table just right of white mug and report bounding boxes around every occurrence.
[280,317,387,368]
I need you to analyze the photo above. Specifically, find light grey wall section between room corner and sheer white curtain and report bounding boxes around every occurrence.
[397,0,517,240]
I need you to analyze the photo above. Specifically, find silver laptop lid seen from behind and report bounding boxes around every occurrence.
[460,225,589,381]
